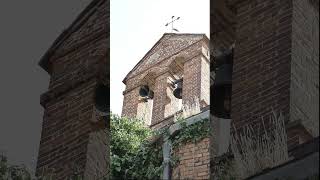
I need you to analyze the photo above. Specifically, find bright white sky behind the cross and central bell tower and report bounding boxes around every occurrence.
[110,0,210,115]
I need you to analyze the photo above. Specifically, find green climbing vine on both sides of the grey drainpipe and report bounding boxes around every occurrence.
[110,115,209,179]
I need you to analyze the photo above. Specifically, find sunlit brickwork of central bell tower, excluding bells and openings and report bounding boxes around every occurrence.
[122,34,209,127]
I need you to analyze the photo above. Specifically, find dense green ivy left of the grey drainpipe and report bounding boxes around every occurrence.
[110,115,163,179]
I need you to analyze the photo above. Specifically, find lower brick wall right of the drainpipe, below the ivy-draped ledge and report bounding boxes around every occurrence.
[172,138,210,179]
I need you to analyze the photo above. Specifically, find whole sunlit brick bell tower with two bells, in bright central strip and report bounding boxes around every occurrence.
[122,33,210,129]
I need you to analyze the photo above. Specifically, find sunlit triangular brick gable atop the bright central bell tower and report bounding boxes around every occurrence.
[123,33,205,83]
